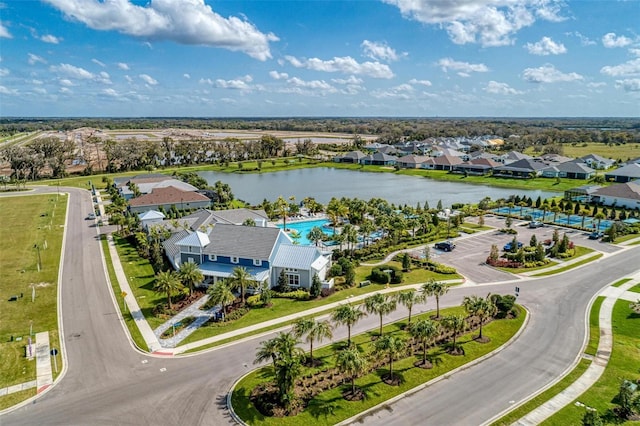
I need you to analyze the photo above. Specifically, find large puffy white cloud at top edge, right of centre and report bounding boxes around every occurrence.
[383,0,564,46]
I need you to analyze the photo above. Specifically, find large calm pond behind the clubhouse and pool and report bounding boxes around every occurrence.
[198,167,558,207]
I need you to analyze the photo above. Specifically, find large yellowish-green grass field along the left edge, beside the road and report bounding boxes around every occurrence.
[0,194,67,406]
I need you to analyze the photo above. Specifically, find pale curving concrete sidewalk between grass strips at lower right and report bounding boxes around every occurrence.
[514,274,640,426]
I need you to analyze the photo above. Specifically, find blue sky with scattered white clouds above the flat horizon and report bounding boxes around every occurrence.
[0,0,640,117]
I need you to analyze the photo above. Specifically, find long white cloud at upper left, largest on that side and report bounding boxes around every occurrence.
[45,0,279,61]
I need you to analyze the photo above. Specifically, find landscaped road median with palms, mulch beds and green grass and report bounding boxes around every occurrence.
[230,307,527,425]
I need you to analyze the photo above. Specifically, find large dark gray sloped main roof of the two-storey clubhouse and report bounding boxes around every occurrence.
[204,223,284,259]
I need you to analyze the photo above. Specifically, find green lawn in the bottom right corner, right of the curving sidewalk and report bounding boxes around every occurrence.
[542,300,640,425]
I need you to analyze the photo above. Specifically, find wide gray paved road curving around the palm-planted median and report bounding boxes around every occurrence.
[0,189,638,426]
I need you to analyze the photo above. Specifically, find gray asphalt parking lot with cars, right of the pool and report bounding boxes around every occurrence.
[431,215,620,284]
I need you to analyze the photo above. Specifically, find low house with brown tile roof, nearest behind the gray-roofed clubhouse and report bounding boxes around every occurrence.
[129,186,211,213]
